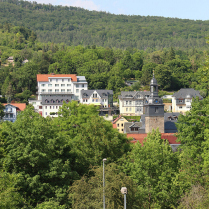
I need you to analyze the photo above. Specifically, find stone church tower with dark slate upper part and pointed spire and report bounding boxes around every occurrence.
[144,71,164,133]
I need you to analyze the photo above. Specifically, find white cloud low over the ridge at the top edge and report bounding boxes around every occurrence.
[60,0,100,11]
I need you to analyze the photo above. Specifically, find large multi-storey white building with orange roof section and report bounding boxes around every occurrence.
[29,73,88,117]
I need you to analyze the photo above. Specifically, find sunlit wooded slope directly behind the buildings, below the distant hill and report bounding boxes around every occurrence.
[0,23,208,102]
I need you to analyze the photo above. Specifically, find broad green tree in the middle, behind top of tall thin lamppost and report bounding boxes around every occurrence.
[54,101,130,175]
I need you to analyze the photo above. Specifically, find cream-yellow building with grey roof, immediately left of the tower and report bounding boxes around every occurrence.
[118,91,150,116]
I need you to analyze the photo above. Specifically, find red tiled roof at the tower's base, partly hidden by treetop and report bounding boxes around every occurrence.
[127,133,181,145]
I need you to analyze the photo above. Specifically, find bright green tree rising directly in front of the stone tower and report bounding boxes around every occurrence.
[124,130,178,208]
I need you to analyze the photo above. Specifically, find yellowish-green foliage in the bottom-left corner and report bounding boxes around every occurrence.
[0,171,24,209]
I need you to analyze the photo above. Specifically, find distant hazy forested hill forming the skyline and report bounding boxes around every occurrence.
[0,0,209,50]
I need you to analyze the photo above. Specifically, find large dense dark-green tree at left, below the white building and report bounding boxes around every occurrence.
[0,107,78,205]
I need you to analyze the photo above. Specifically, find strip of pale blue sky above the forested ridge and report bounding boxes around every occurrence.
[32,0,209,20]
